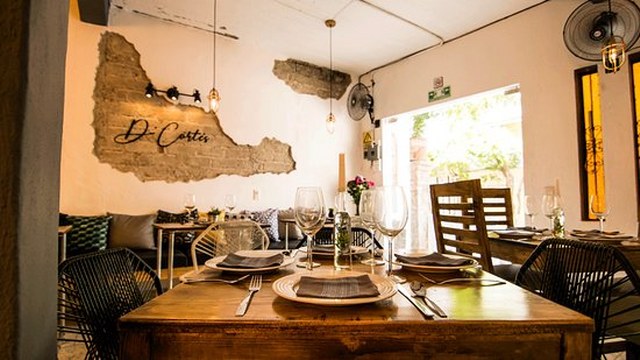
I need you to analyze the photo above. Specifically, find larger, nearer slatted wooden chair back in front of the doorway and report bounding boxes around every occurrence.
[430,179,493,272]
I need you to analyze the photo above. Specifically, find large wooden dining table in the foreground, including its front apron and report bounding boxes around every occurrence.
[118,256,593,360]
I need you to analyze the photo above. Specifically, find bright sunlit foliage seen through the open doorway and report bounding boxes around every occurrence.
[412,94,522,187]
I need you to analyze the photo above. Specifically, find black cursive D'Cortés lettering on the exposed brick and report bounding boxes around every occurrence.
[113,119,209,148]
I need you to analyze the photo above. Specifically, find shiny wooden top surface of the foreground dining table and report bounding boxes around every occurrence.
[121,256,591,331]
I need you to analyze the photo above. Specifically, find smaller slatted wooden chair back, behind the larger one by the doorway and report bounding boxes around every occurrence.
[482,188,513,230]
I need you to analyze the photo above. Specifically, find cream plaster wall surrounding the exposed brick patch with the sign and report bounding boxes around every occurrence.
[60,2,360,214]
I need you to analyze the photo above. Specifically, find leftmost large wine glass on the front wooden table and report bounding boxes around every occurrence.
[293,186,327,270]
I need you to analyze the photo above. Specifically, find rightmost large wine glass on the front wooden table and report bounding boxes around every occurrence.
[373,186,408,283]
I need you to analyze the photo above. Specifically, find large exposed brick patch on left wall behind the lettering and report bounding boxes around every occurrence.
[92,32,295,182]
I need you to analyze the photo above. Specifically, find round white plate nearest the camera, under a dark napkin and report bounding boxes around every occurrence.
[272,271,398,306]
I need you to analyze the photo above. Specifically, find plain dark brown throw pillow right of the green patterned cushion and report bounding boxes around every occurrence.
[107,213,156,249]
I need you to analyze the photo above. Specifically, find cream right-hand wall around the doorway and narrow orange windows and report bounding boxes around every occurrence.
[358,0,637,234]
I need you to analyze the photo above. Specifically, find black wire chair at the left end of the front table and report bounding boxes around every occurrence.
[58,248,162,359]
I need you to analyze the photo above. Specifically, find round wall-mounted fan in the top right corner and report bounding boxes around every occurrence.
[563,0,640,61]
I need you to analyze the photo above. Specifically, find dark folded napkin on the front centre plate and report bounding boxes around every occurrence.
[296,274,380,299]
